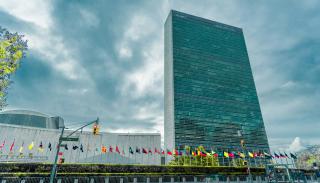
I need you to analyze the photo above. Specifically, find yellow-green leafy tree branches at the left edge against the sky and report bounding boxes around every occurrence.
[0,26,28,110]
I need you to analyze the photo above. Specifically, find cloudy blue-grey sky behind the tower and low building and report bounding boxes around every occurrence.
[0,0,320,150]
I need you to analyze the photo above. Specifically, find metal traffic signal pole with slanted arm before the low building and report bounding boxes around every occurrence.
[50,118,99,183]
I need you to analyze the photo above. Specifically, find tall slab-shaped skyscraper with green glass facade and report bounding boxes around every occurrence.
[164,10,269,151]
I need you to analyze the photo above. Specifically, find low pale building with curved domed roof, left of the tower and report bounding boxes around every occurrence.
[0,110,161,165]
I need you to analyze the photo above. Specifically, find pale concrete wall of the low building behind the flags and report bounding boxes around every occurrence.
[0,124,161,165]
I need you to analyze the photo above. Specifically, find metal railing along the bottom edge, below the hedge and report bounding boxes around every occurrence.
[0,175,320,183]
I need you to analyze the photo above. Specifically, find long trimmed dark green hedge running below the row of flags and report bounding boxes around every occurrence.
[0,163,265,177]
